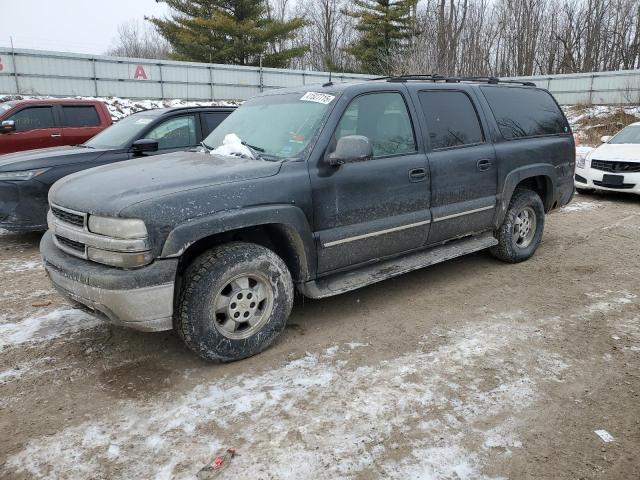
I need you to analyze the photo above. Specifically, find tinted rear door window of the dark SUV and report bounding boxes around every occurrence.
[418,90,484,150]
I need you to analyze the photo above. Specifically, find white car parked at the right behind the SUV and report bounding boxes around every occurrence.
[575,122,640,194]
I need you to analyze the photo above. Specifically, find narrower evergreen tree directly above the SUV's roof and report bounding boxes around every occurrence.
[345,0,418,75]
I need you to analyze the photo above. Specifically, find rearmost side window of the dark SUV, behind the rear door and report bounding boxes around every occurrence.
[481,87,569,140]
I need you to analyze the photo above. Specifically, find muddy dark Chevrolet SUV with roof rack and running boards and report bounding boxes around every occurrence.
[41,76,575,361]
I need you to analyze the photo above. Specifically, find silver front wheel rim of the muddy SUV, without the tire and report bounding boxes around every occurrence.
[212,273,273,340]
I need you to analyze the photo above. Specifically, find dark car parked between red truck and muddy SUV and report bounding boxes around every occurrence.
[0,107,234,231]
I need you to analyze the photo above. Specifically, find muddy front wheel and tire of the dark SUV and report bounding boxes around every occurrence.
[174,242,293,362]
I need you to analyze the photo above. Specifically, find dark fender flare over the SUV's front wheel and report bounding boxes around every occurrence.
[160,204,316,278]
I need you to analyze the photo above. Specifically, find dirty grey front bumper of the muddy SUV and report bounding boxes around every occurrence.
[40,232,178,332]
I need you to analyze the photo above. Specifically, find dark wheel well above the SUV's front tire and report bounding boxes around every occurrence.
[178,224,309,282]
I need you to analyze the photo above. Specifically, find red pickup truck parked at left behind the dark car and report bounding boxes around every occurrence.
[0,99,112,154]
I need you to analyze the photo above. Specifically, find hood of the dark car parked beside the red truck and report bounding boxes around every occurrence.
[0,147,105,172]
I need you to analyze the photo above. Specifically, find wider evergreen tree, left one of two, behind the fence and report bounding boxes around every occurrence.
[149,0,306,67]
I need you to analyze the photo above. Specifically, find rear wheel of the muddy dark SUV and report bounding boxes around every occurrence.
[491,188,544,263]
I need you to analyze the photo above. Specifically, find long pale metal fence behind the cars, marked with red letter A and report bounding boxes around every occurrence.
[5,47,640,105]
